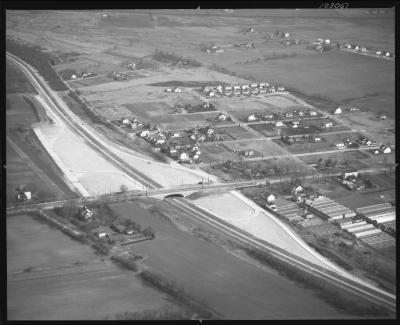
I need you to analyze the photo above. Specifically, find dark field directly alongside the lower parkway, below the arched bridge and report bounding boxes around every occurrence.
[109,203,346,319]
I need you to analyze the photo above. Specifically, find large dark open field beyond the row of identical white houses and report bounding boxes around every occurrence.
[226,50,394,113]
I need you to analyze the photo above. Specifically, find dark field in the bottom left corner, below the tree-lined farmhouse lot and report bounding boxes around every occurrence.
[7,215,179,320]
